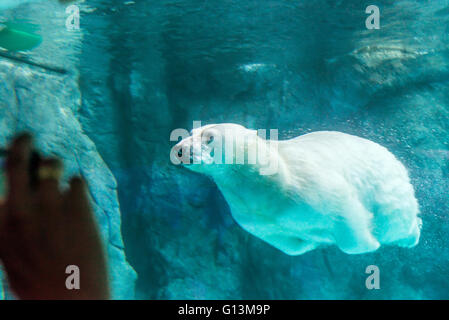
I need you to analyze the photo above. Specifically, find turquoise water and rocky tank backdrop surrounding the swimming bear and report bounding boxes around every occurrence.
[0,0,449,299]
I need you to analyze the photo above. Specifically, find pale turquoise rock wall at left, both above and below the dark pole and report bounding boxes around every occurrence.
[0,3,136,299]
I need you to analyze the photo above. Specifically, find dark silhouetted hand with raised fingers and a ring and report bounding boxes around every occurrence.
[0,135,109,299]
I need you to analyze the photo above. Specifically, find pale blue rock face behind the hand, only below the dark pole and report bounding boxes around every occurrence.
[0,60,135,299]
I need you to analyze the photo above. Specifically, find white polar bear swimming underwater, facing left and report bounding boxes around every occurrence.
[172,123,421,255]
